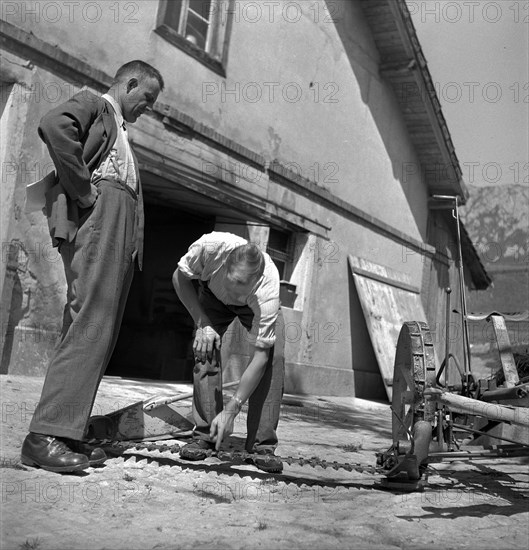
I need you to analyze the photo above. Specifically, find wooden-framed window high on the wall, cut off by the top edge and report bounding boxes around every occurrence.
[154,0,234,77]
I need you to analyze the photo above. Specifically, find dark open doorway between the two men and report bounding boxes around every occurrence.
[106,203,215,382]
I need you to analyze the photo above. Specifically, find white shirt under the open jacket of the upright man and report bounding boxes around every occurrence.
[92,94,138,191]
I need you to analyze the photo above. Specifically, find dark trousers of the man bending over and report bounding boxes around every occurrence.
[193,282,285,452]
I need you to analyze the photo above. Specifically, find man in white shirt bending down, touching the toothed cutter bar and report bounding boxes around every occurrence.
[173,232,284,472]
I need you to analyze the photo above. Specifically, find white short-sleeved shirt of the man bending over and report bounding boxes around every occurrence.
[178,231,279,348]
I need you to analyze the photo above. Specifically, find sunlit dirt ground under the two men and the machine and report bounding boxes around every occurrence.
[0,375,529,550]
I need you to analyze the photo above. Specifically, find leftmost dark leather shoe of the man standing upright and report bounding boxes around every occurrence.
[21,432,90,472]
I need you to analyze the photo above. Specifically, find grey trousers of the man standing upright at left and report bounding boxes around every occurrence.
[29,180,138,440]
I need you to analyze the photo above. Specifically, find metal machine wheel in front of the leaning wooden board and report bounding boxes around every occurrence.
[392,321,436,456]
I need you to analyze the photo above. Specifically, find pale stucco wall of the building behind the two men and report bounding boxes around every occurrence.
[2,1,470,395]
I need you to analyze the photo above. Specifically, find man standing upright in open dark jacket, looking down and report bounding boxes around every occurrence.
[22,61,164,472]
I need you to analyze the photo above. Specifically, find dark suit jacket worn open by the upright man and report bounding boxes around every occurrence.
[38,91,144,269]
